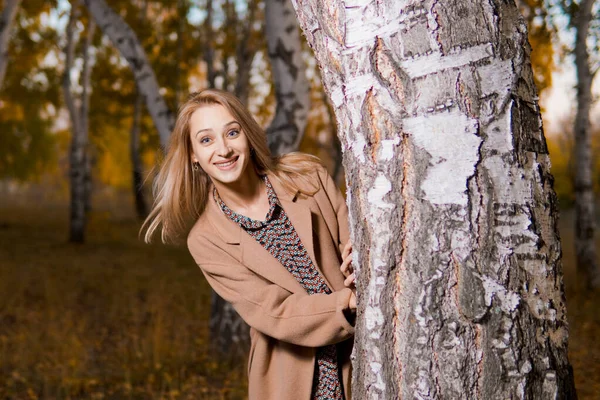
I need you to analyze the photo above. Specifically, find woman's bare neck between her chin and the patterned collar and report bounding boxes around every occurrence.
[213,168,268,214]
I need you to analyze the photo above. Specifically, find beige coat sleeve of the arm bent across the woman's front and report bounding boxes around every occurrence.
[188,231,354,347]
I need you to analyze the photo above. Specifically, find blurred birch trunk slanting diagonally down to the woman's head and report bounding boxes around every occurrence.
[83,0,174,148]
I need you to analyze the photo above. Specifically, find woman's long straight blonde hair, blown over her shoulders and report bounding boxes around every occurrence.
[140,89,321,243]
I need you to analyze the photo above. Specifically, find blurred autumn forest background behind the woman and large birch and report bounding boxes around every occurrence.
[0,0,600,399]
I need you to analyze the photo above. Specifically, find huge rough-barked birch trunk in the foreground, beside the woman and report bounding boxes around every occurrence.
[294,0,576,399]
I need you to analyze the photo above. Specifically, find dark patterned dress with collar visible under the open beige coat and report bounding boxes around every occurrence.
[213,176,343,400]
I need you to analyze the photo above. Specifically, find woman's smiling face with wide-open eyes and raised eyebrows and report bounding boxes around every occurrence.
[190,104,253,185]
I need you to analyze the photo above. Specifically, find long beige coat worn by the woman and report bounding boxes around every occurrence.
[187,169,354,400]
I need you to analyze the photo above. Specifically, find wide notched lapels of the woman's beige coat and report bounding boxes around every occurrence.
[205,173,316,293]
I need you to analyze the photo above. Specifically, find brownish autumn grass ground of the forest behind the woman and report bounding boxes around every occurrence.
[0,188,600,400]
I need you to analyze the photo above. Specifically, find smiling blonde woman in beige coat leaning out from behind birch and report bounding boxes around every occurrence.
[142,90,356,400]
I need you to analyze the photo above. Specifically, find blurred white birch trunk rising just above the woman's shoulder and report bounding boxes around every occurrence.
[265,0,310,155]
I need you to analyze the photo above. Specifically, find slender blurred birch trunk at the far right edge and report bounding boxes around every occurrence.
[574,0,600,288]
